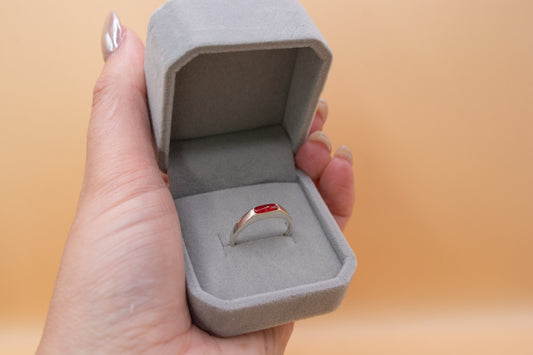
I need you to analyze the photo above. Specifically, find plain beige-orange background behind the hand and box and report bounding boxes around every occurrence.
[0,0,533,354]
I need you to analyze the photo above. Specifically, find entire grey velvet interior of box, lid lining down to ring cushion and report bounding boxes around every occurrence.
[168,47,342,300]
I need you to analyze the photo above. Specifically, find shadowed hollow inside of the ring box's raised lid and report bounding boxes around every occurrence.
[171,47,324,143]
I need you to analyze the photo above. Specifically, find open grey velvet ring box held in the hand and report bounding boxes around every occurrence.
[145,0,356,336]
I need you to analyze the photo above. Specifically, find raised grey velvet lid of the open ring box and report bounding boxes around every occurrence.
[145,0,332,171]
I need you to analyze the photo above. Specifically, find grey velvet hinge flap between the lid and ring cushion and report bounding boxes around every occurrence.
[168,125,296,198]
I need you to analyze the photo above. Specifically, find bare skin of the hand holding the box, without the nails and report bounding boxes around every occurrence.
[38,29,354,354]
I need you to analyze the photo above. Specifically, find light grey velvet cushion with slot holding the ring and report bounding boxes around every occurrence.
[175,172,344,300]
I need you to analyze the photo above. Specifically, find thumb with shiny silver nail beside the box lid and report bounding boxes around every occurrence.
[83,13,164,196]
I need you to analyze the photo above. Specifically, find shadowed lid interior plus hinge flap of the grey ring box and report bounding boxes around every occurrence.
[168,47,323,198]
